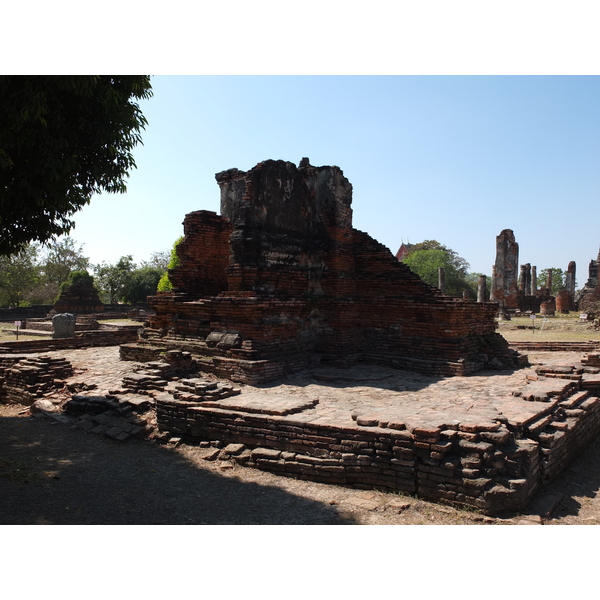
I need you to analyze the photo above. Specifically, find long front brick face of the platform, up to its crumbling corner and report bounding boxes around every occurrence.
[157,396,540,514]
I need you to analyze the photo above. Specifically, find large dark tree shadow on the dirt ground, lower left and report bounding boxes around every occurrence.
[0,417,354,525]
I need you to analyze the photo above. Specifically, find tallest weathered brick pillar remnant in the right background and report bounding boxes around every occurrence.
[490,229,519,311]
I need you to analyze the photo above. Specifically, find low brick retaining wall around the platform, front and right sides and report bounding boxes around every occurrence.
[157,381,600,514]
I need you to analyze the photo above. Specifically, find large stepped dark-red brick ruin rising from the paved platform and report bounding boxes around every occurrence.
[134,159,518,384]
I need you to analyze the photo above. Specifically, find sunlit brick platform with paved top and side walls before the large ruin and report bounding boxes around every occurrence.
[156,358,600,514]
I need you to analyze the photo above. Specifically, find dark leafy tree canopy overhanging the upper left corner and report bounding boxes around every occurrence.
[0,75,152,256]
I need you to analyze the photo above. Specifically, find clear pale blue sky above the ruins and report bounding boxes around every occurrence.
[72,76,600,285]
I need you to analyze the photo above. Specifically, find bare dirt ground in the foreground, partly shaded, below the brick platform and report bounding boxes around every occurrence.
[0,398,600,525]
